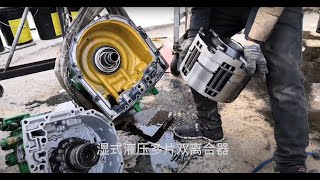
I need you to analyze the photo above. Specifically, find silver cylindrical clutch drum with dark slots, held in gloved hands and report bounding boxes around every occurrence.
[179,29,252,103]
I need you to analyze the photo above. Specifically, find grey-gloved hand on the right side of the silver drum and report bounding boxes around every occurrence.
[244,44,268,80]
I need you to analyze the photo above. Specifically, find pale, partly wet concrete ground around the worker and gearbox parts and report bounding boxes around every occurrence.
[0,8,320,173]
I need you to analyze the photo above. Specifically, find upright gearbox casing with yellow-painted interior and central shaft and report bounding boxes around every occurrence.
[69,15,168,120]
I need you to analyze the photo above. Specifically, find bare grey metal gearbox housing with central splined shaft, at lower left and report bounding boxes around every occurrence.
[20,108,123,173]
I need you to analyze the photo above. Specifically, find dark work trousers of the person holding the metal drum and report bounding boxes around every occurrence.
[188,7,309,168]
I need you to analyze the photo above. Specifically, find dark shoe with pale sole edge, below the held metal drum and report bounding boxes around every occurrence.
[173,122,224,143]
